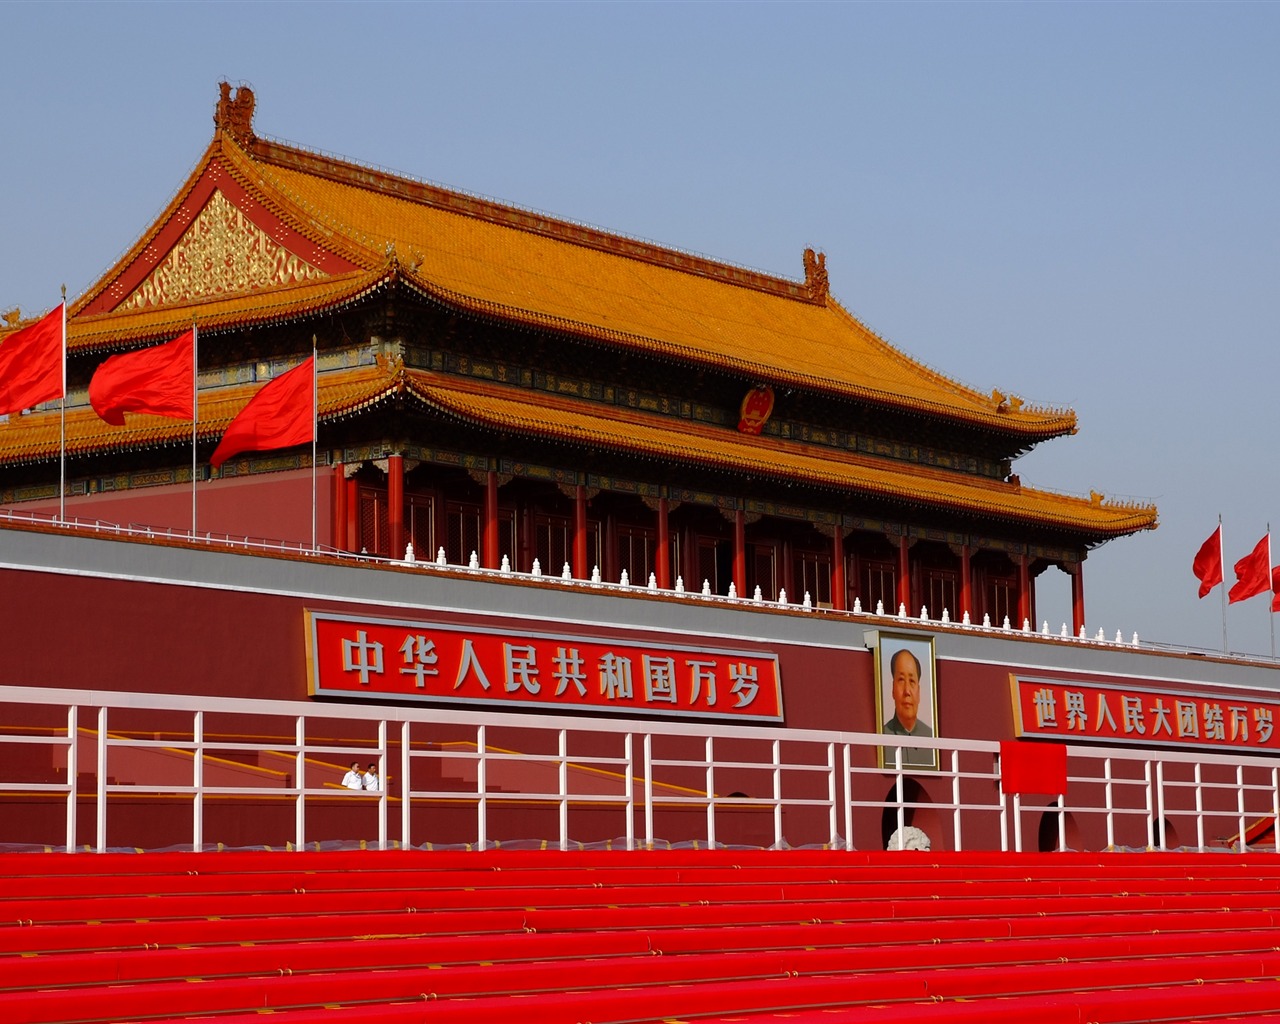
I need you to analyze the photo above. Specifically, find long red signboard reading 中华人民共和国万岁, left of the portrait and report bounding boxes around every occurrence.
[306,612,782,722]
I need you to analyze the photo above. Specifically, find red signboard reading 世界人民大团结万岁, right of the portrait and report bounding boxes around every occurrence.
[1010,676,1280,751]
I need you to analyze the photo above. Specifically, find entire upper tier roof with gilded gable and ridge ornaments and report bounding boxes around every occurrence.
[37,86,1075,448]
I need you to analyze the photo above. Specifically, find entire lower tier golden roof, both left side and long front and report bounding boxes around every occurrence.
[0,366,1156,540]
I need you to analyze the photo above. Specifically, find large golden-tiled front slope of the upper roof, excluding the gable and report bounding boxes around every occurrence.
[261,149,1075,438]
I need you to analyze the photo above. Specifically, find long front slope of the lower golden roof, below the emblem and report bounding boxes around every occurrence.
[407,370,1156,539]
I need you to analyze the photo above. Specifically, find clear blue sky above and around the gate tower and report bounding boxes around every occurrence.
[0,0,1280,654]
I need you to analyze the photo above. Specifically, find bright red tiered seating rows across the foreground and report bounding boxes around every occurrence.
[0,850,1280,1024]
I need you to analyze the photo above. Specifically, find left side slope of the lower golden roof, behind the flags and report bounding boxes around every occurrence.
[0,366,399,466]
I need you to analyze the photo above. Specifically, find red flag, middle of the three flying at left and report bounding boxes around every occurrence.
[88,330,196,426]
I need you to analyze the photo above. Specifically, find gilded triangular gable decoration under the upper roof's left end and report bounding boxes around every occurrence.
[116,192,325,310]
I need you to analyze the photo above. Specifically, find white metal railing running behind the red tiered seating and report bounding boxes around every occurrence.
[0,686,1280,852]
